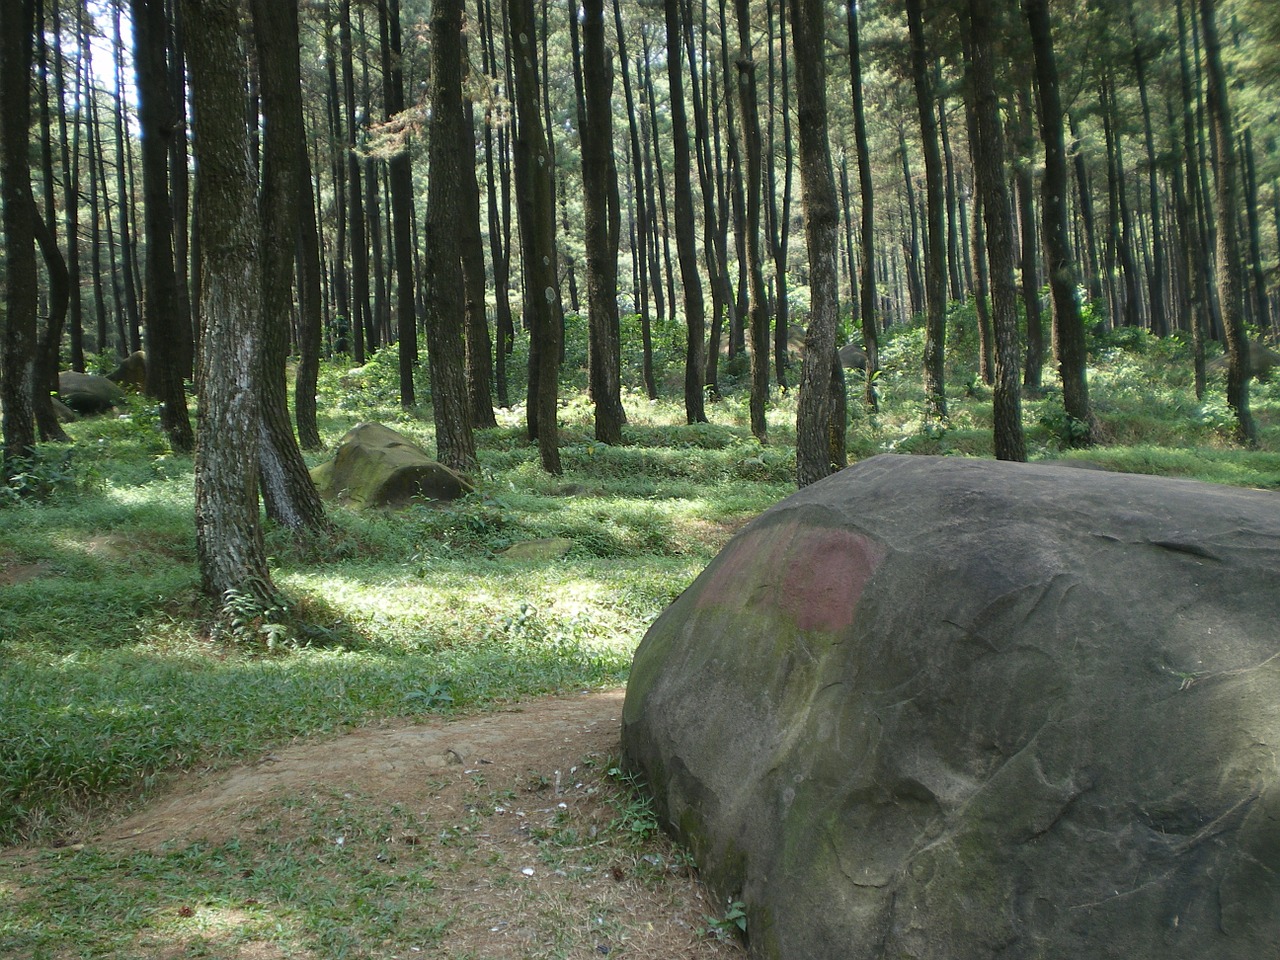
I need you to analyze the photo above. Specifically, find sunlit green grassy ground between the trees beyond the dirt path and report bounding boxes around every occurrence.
[0,324,1280,956]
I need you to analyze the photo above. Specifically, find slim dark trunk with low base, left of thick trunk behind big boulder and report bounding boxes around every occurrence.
[733,0,769,443]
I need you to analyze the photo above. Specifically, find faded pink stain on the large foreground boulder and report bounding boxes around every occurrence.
[698,524,886,634]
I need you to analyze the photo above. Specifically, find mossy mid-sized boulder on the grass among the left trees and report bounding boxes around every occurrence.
[311,424,475,507]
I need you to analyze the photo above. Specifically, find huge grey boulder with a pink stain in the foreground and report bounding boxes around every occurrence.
[622,456,1280,960]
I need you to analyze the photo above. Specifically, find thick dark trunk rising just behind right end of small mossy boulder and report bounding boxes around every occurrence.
[426,0,476,471]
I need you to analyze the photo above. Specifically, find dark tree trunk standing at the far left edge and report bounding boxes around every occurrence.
[0,0,38,481]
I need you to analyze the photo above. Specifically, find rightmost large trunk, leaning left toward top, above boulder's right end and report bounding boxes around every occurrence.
[1199,0,1258,447]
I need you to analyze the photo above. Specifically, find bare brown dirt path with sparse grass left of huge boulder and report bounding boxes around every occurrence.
[0,690,742,960]
